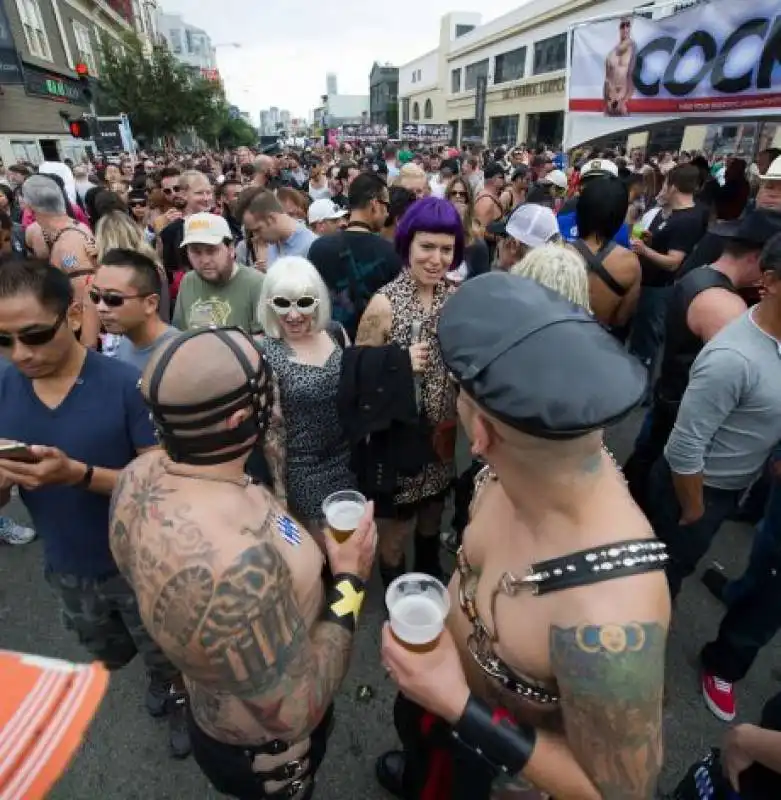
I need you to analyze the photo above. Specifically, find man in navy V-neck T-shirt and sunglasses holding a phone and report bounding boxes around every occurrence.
[0,261,189,757]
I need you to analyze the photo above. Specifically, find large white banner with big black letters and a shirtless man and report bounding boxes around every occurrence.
[565,0,781,148]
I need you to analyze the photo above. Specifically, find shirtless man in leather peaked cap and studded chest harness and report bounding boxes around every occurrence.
[377,273,670,800]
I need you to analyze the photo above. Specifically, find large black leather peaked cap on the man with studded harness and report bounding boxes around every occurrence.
[438,272,648,439]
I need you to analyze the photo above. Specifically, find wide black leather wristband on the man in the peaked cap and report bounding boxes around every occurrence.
[453,694,537,775]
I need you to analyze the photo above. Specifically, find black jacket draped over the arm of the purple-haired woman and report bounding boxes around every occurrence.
[337,344,435,497]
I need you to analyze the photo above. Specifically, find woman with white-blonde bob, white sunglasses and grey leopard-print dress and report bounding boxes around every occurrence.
[258,256,355,545]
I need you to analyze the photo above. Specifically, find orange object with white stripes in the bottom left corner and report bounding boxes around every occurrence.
[0,650,108,800]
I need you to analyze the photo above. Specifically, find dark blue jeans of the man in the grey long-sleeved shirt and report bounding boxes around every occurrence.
[648,456,743,600]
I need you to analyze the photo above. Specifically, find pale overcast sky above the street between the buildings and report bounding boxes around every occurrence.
[161,0,524,124]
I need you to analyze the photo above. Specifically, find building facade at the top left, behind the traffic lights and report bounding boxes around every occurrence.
[0,0,136,165]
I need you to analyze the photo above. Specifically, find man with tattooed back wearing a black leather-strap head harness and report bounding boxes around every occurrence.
[111,328,376,800]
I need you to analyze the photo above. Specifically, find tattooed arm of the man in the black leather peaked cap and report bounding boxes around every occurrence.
[550,622,667,800]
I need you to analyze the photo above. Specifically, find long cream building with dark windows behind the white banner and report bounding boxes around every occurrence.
[399,0,728,149]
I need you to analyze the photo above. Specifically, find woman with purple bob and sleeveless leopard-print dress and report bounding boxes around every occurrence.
[356,197,464,586]
